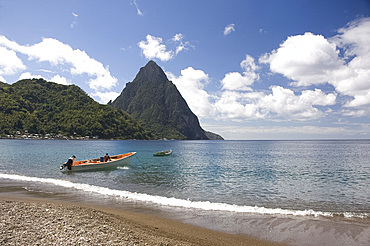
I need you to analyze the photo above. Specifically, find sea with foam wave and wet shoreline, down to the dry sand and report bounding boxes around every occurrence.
[0,139,370,246]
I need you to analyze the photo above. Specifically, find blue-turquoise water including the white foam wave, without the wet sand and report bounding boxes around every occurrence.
[0,140,370,245]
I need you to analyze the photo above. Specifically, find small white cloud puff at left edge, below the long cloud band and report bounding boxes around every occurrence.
[0,45,26,75]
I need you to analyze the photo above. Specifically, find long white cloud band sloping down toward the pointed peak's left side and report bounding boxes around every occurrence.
[0,36,117,90]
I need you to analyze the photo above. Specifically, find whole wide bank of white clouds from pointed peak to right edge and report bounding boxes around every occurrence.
[156,18,370,122]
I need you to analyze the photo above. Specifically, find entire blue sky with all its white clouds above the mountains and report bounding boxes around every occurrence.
[0,0,370,140]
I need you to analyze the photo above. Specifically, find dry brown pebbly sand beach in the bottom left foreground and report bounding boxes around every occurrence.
[0,195,280,246]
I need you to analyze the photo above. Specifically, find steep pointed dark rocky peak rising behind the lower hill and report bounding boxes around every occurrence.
[112,61,222,140]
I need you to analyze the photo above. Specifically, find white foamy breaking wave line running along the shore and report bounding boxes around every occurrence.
[0,173,370,218]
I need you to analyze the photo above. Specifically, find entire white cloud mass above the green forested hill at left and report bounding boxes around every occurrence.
[0,34,117,102]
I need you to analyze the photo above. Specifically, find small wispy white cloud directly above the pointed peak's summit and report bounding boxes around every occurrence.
[138,33,190,61]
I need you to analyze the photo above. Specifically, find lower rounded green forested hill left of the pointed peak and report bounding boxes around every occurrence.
[0,79,151,139]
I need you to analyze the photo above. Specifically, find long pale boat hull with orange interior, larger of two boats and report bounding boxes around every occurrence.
[60,152,136,173]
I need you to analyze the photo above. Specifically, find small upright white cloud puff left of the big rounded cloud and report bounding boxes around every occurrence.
[221,55,259,91]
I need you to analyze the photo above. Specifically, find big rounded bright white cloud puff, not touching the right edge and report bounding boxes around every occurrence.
[260,33,342,86]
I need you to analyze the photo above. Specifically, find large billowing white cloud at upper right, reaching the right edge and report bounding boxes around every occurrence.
[260,18,370,116]
